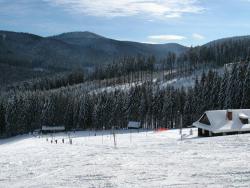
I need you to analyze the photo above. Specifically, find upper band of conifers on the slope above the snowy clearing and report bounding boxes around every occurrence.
[4,37,250,93]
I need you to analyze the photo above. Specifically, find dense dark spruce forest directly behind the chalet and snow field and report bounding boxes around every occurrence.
[0,62,250,136]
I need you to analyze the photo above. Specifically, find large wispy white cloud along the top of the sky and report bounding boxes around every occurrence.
[43,0,205,19]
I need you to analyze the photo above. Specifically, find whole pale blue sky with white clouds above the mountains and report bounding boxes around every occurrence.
[0,0,250,46]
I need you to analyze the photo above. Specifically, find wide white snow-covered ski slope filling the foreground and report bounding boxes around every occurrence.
[0,129,250,188]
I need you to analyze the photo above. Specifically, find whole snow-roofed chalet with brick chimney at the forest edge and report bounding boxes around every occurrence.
[193,109,250,137]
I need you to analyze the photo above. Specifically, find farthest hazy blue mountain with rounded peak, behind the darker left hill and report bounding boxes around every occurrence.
[51,31,187,58]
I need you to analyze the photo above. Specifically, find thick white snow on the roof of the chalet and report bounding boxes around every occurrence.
[193,109,250,133]
